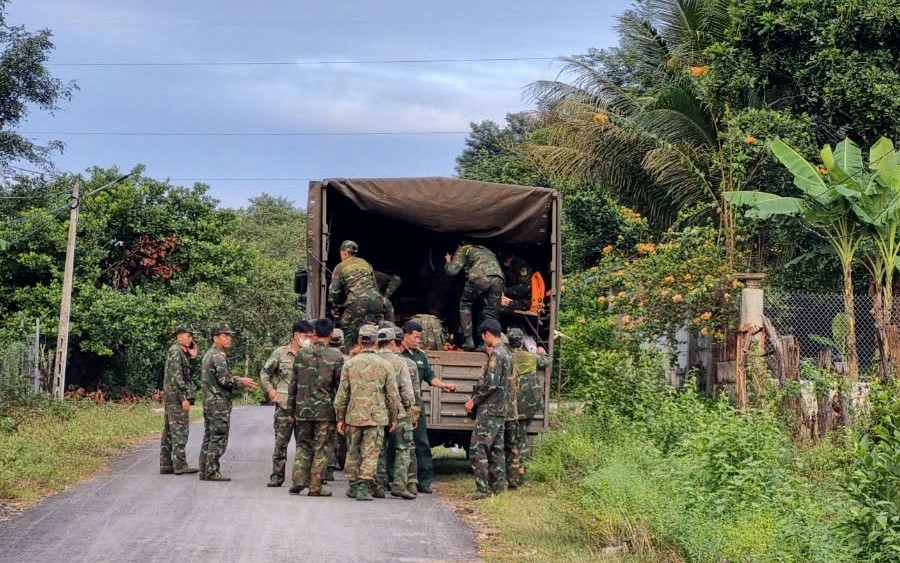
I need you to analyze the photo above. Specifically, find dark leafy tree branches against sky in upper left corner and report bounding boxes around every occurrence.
[0,0,77,168]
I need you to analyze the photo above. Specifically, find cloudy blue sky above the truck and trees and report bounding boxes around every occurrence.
[7,0,630,207]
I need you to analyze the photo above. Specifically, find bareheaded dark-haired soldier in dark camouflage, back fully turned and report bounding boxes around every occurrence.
[287,319,344,497]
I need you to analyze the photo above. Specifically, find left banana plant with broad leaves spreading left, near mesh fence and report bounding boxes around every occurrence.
[725,140,864,381]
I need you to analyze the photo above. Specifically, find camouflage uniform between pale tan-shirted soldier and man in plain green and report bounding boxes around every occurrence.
[376,349,416,490]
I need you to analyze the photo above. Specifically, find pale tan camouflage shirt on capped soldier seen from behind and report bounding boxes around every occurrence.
[334,350,406,426]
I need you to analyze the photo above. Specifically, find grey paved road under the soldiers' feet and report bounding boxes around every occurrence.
[0,407,476,563]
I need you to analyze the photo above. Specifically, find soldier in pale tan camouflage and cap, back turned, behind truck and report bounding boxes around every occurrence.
[334,325,406,501]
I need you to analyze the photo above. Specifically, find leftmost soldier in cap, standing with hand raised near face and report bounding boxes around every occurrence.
[159,325,200,475]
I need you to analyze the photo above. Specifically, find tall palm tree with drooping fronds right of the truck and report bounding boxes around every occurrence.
[528,0,734,255]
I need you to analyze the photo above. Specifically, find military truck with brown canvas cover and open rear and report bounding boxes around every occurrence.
[295,177,562,448]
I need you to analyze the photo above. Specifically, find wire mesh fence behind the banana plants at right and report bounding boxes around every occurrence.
[764,293,880,370]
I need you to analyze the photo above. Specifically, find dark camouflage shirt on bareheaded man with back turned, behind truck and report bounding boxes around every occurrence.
[287,342,344,421]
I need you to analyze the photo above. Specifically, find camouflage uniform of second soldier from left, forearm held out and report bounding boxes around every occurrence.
[200,346,241,477]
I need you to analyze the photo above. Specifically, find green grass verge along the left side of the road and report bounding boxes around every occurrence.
[0,401,165,503]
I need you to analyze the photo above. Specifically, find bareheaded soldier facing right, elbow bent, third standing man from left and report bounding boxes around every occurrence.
[259,321,313,487]
